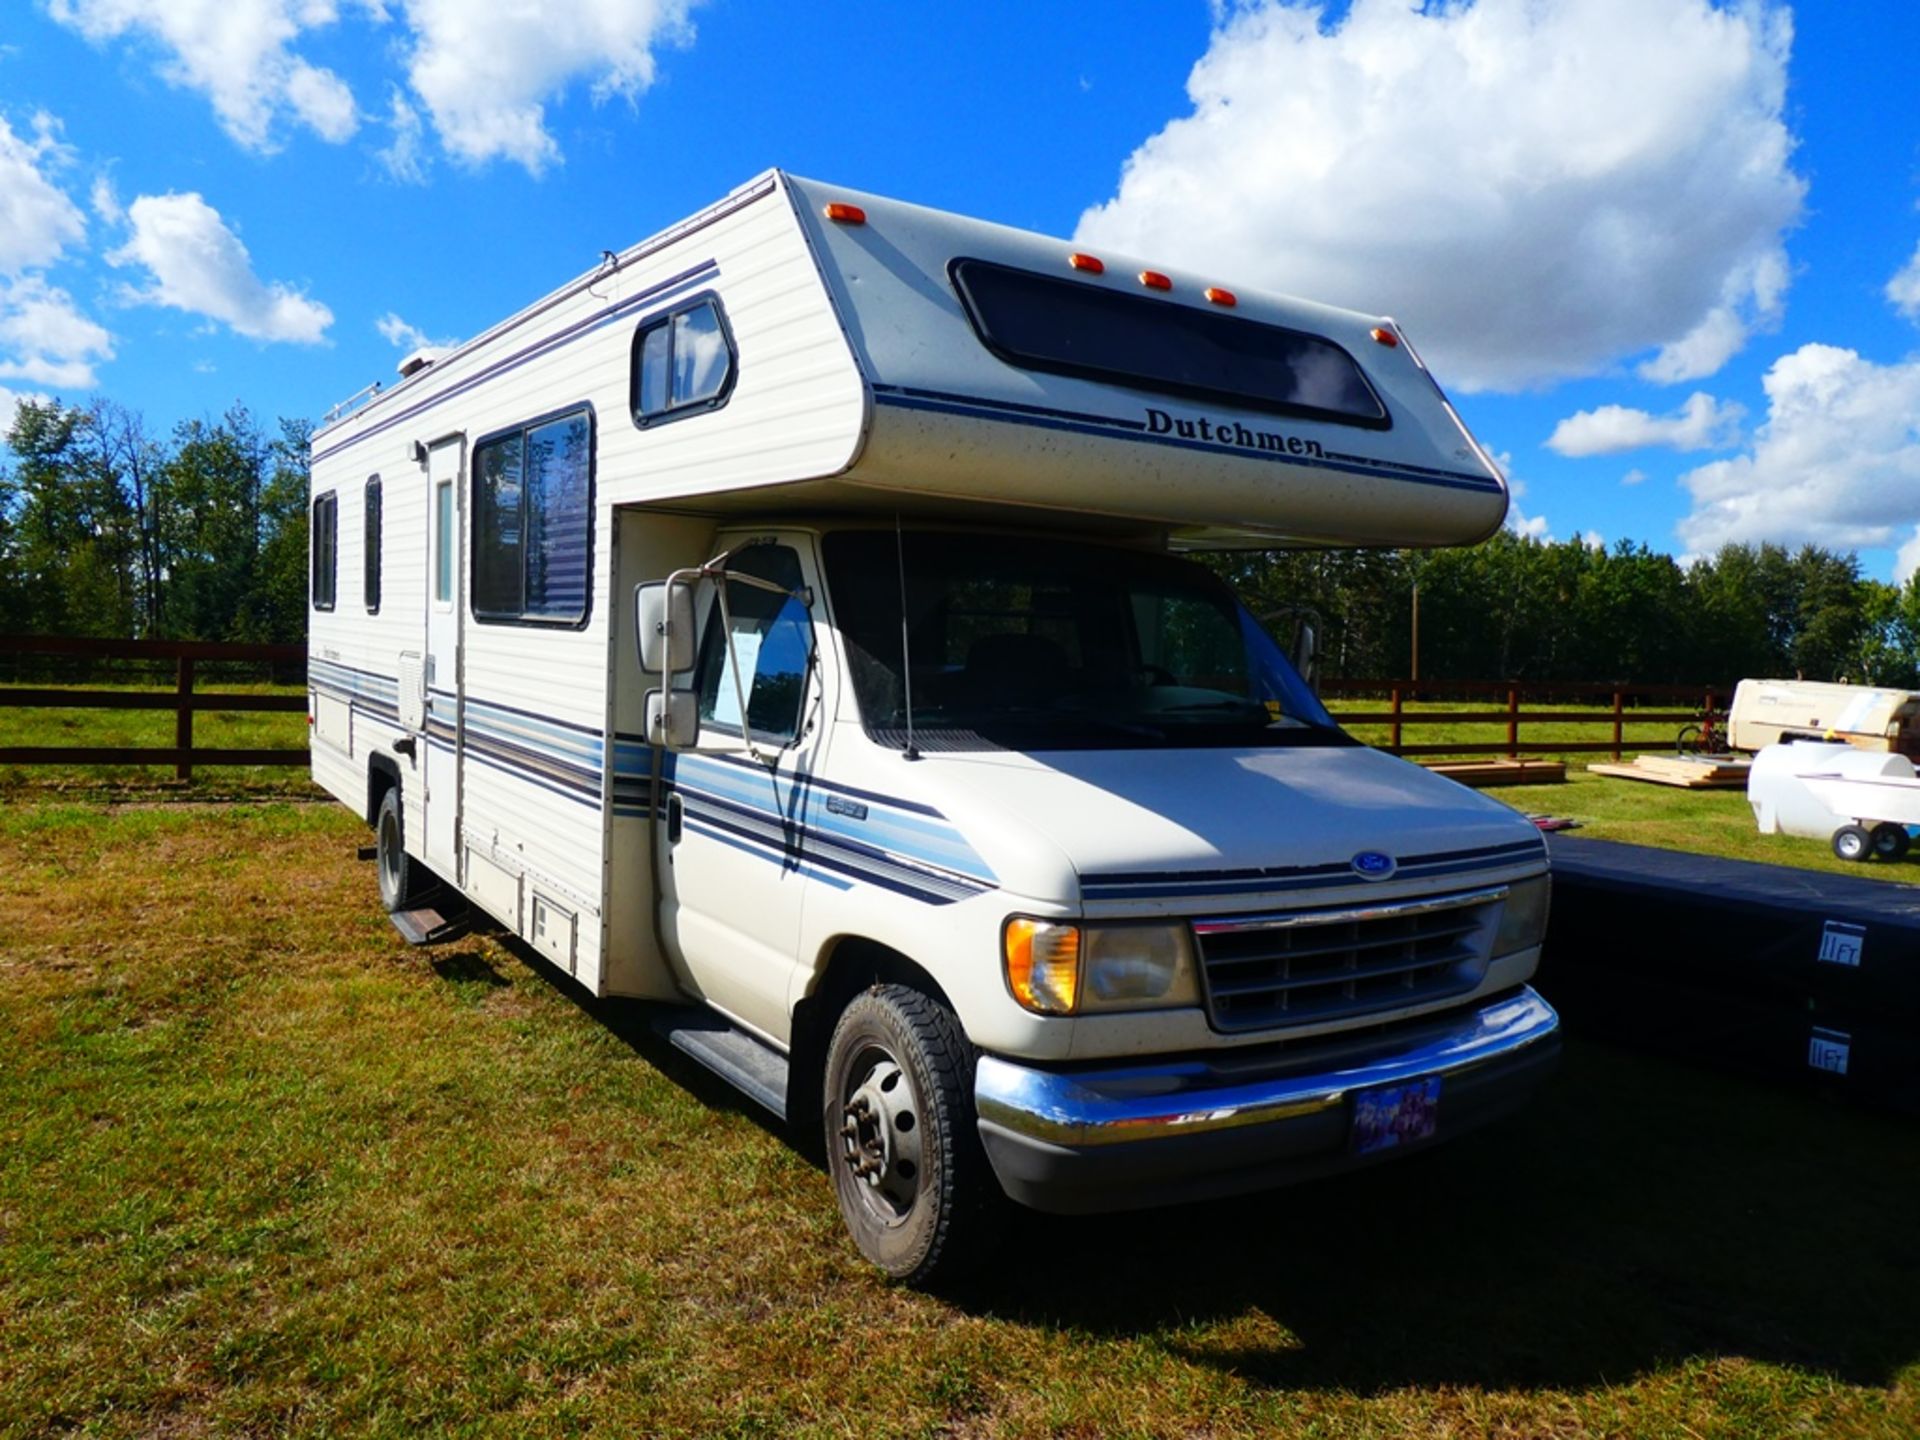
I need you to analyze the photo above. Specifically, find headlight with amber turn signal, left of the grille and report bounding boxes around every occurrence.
[1002,916,1200,1016]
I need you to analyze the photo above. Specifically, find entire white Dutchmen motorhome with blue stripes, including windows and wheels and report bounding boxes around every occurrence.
[309,171,1557,1279]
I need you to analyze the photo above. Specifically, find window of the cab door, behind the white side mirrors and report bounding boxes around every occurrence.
[699,545,814,745]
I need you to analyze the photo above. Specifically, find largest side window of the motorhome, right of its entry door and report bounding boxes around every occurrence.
[472,409,593,626]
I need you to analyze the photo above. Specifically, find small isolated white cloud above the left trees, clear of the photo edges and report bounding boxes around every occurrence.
[108,194,334,344]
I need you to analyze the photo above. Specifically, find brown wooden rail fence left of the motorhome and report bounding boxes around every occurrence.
[0,636,307,780]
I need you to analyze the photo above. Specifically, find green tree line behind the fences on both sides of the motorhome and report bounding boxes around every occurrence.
[0,399,1920,685]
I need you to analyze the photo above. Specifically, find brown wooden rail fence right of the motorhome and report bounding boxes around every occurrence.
[1321,680,1732,760]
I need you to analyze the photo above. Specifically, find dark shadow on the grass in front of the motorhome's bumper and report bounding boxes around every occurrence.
[950,1041,1920,1394]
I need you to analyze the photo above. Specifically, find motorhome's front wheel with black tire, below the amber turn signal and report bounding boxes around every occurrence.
[822,985,1006,1284]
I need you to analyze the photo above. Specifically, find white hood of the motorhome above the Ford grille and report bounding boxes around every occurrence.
[914,745,1546,910]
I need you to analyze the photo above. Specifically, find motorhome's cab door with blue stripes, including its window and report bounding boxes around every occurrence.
[659,538,828,1043]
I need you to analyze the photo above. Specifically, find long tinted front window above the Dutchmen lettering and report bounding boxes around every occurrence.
[952,259,1390,430]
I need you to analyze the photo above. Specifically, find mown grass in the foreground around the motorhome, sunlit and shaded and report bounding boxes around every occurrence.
[0,806,1920,1438]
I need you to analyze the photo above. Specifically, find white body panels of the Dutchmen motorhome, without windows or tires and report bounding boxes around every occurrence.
[309,171,1555,1273]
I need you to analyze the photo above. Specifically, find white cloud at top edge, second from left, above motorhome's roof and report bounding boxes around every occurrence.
[403,0,695,175]
